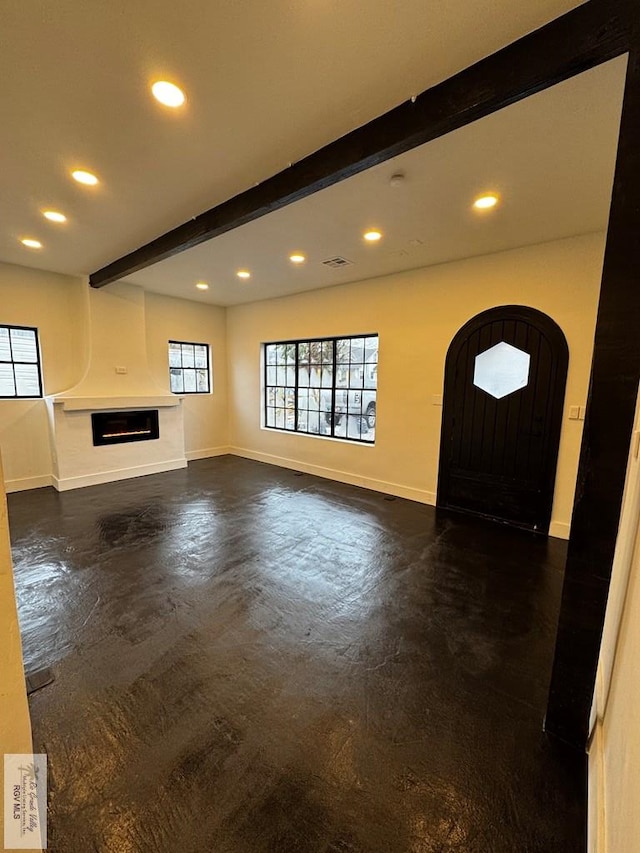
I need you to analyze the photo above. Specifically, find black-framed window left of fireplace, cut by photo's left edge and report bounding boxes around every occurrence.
[0,325,42,400]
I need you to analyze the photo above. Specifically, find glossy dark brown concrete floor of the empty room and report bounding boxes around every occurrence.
[9,457,585,853]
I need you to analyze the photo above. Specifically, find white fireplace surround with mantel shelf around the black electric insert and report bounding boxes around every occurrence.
[47,394,187,492]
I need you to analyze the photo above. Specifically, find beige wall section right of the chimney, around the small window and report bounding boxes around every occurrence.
[146,293,229,459]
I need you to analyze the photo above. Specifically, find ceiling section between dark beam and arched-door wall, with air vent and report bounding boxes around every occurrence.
[127,57,626,305]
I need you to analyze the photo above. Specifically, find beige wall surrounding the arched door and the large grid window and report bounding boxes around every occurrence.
[227,234,604,537]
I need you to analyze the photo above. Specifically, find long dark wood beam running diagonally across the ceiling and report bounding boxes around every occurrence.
[89,0,630,287]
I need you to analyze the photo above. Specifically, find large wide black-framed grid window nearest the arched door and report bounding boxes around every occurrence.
[264,334,378,444]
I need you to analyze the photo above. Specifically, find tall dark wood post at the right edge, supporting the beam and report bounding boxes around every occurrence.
[545,41,640,747]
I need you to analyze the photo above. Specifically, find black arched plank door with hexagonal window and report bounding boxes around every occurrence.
[438,305,569,533]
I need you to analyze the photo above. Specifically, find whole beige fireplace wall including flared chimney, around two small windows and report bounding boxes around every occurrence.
[0,264,227,491]
